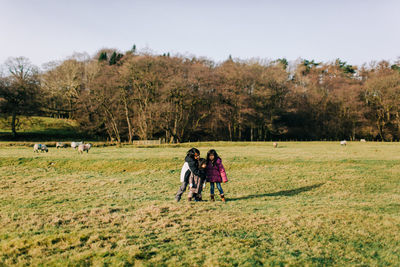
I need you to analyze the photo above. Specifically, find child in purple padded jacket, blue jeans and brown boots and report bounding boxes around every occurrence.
[206,149,228,202]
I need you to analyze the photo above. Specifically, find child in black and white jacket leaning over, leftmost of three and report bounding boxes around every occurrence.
[175,147,206,202]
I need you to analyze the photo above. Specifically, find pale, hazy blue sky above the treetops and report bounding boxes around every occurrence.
[0,0,400,67]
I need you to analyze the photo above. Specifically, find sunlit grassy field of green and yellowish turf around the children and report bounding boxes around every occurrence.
[0,142,400,266]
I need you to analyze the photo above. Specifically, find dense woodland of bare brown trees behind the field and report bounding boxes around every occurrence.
[0,46,400,142]
